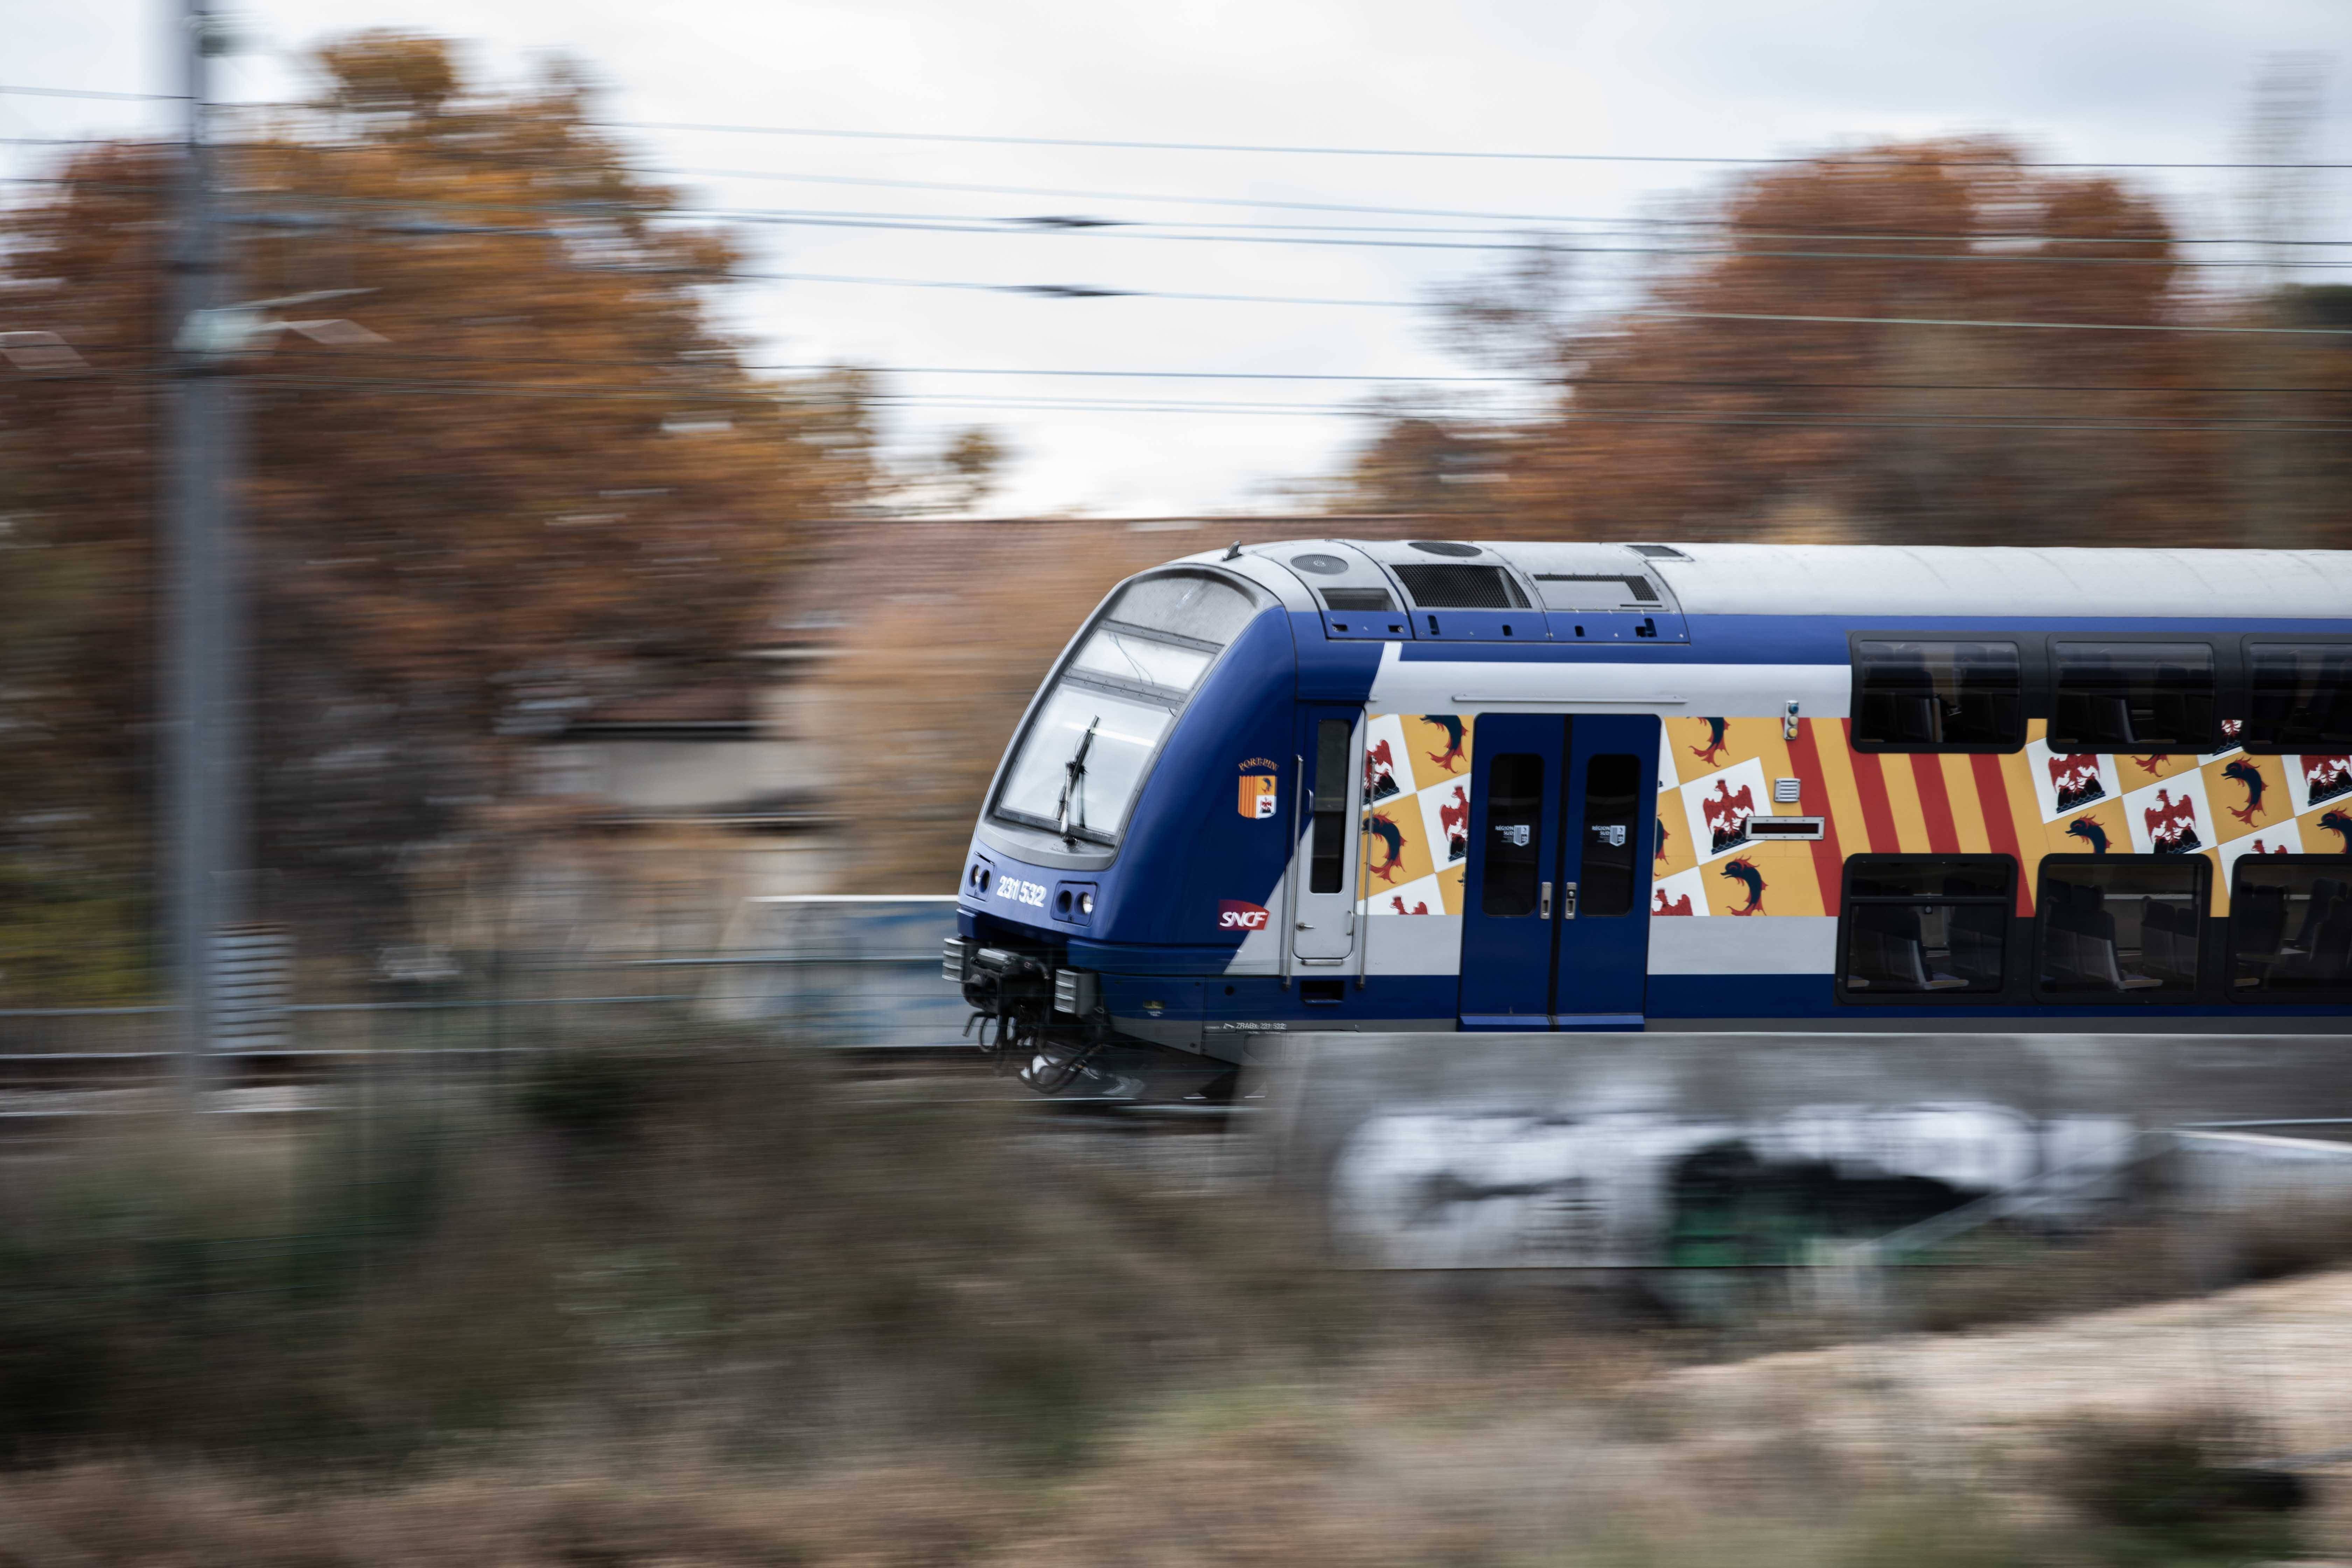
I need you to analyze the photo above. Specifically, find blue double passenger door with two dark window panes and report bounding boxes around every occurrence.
[1461,715,1658,1030]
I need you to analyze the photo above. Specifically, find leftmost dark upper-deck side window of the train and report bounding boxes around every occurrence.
[1853,642,2025,752]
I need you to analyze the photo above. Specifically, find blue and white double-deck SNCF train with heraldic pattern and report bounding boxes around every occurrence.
[943,538,2352,1102]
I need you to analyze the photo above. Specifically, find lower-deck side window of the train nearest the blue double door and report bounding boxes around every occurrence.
[1839,856,2018,999]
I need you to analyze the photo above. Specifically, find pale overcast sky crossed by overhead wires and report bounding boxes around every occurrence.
[0,0,2352,515]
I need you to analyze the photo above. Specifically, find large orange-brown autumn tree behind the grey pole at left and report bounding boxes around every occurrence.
[0,33,873,987]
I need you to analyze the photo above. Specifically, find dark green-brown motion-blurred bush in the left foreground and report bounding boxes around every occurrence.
[0,1039,1350,1462]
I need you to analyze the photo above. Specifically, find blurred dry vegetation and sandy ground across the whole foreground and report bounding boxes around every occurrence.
[0,1039,2352,1568]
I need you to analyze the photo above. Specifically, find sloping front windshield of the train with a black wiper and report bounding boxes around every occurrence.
[997,571,1258,844]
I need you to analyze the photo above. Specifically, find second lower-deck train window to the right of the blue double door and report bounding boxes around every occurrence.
[2035,856,2213,1001]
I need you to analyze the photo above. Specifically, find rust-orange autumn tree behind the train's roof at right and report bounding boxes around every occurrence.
[1352,139,2352,543]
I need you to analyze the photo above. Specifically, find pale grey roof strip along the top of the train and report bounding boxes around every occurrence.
[1223,538,2352,618]
